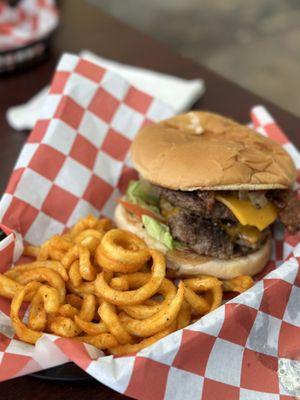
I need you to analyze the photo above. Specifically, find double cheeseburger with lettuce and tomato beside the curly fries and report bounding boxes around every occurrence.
[115,111,300,279]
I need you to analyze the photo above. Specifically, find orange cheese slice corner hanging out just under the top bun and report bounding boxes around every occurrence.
[216,195,278,231]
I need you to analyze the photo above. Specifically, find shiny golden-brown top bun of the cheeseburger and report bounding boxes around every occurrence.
[131,111,296,190]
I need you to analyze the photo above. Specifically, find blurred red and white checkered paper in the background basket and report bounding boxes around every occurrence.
[0,0,58,51]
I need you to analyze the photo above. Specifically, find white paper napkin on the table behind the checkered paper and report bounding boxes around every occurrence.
[6,50,205,130]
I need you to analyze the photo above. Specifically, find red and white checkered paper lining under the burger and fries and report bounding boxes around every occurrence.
[0,55,300,400]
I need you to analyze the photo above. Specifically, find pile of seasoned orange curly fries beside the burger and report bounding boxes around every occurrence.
[0,215,253,356]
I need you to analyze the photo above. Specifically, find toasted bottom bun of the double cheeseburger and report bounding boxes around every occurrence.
[115,204,272,279]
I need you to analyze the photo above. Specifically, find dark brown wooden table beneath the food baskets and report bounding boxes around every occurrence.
[0,0,300,400]
